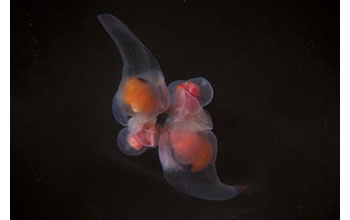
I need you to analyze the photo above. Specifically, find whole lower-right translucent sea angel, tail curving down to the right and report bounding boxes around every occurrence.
[159,78,245,200]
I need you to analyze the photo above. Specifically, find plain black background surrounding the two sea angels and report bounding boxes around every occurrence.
[11,0,340,220]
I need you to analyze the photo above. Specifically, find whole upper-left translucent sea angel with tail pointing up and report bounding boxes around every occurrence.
[98,14,170,154]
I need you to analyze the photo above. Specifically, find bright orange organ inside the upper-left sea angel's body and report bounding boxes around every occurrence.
[123,77,158,113]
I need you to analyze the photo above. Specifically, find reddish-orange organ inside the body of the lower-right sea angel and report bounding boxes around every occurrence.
[171,130,213,172]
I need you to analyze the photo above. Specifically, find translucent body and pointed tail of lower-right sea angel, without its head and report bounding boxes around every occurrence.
[159,129,245,201]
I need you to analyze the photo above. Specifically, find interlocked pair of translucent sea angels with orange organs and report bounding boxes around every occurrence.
[98,14,246,201]
